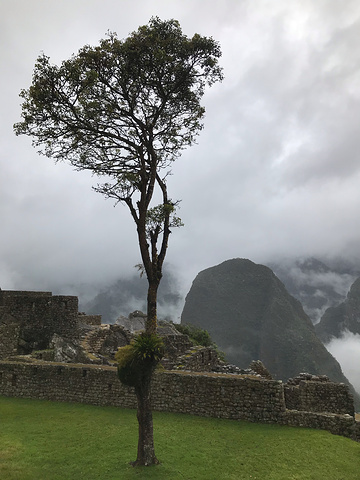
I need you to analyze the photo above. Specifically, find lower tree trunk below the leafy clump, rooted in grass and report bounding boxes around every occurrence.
[132,369,159,467]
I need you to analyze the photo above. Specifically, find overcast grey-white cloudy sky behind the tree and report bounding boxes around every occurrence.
[0,0,360,294]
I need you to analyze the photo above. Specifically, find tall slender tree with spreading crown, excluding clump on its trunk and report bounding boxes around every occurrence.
[14,17,222,464]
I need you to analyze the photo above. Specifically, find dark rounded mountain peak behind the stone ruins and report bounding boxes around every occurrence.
[181,259,358,402]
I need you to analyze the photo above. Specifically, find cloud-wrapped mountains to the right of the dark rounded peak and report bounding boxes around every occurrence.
[269,256,360,392]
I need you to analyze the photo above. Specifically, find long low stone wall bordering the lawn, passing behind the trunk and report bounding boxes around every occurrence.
[0,361,360,441]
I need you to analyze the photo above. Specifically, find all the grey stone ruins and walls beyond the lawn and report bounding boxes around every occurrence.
[0,290,360,441]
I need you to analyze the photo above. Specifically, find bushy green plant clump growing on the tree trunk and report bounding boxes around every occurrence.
[115,333,164,387]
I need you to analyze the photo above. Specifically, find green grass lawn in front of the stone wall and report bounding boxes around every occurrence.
[0,397,360,480]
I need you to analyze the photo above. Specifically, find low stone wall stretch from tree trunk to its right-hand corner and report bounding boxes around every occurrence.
[154,372,285,423]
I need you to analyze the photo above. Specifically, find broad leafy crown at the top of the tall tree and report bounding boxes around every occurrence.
[14,17,222,182]
